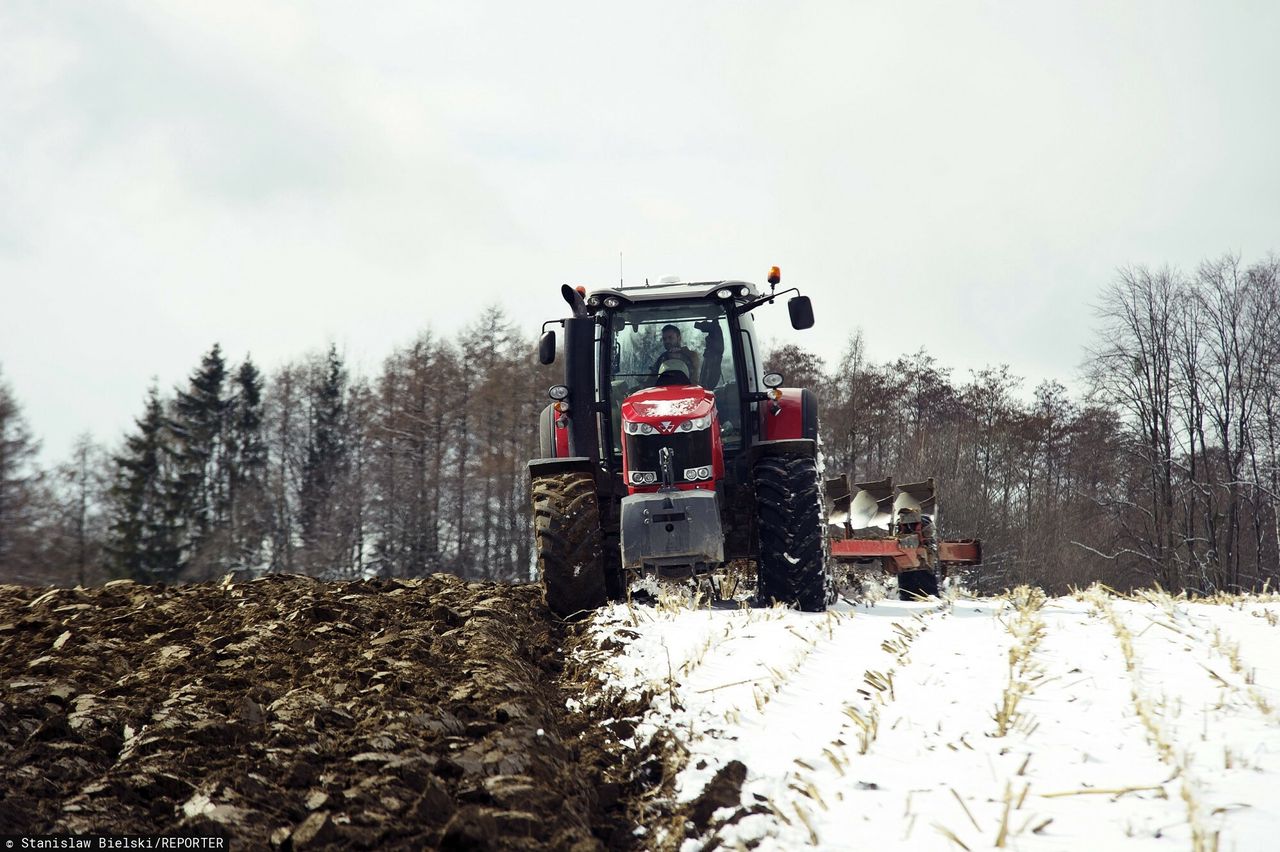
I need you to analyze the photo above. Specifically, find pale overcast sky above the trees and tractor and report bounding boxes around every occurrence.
[0,0,1280,462]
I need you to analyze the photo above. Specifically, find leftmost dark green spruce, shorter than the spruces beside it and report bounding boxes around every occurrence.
[108,388,183,582]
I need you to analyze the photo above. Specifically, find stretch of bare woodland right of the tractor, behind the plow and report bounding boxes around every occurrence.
[768,256,1280,594]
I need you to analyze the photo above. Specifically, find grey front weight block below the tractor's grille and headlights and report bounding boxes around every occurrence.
[622,490,724,572]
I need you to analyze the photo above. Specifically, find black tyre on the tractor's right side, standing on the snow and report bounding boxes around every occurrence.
[754,457,831,613]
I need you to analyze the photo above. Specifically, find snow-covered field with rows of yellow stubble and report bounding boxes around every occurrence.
[595,588,1280,852]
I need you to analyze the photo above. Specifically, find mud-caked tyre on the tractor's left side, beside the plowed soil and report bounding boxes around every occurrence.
[532,473,608,619]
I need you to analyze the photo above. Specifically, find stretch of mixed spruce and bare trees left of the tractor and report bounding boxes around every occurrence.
[0,307,556,583]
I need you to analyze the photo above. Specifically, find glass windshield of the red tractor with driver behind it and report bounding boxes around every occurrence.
[609,302,742,452]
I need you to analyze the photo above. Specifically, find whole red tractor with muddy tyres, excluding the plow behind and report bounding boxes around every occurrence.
[529,267,833,618]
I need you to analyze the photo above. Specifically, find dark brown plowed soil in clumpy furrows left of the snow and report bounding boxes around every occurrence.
[0,576,660,849]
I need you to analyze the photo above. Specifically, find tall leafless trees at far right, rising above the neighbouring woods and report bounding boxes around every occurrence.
[1088,256,1280,590]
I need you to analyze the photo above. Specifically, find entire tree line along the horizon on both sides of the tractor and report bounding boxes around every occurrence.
[0,257,1280,592]
